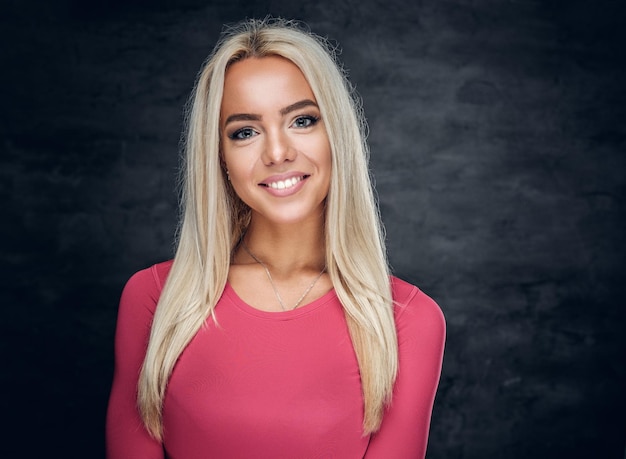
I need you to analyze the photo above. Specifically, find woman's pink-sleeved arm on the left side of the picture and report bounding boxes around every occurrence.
[106,268,164,459]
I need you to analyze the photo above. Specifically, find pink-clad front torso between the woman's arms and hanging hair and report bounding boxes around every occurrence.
[163,296,367,458]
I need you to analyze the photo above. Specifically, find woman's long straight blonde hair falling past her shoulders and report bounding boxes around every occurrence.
[138,19,398,439]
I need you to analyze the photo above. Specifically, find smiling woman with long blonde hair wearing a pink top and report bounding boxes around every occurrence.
[107,20,445,459]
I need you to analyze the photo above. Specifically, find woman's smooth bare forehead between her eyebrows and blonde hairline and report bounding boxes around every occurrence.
[221,56,316,114]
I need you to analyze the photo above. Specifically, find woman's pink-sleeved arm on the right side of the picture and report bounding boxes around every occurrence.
[365,287,446,459]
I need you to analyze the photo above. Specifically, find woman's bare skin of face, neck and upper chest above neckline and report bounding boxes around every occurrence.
[220,56,332,311]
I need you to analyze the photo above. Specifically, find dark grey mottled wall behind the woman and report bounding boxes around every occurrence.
[0,0,626,459]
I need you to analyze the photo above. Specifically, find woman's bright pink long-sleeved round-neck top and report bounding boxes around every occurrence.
[106,262,445,459]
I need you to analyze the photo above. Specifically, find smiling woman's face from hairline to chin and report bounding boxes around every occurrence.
[220,56,331,228]
